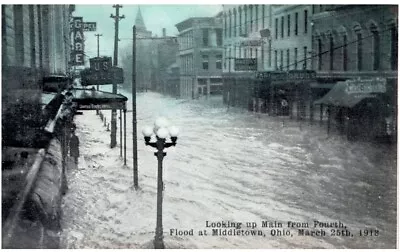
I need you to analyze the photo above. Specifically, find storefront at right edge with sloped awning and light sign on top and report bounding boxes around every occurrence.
[315,77,397,140]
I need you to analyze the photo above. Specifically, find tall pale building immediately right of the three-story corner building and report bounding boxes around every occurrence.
[223,5,274,108]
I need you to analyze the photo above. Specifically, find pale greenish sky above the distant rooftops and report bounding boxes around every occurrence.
[73,4,222,62]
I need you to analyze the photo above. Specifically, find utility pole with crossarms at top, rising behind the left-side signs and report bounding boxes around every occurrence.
[110,4,125,148]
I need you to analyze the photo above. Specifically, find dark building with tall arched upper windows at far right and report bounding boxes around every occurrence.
[312,5,398,138]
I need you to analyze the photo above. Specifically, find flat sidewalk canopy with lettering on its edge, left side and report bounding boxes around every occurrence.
[71,88,128,110]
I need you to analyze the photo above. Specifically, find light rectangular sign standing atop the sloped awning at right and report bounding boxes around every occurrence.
[345,78,386,94]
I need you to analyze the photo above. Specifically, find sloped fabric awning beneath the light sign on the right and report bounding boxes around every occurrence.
[314,81,377,108]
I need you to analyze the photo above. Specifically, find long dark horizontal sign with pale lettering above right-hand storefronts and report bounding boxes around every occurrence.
[256,70,317,81]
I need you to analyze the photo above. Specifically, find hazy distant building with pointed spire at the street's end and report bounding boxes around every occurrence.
[135,7,153,90]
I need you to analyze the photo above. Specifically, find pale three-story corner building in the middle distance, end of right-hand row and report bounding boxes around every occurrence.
[175,13,223,99]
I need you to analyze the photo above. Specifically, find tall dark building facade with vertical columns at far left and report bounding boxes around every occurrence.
[2,5,74,145]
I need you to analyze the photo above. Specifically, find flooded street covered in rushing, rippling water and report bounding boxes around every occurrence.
[61,92,397,249]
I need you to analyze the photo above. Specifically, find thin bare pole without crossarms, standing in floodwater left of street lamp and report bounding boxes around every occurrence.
[132,25,139,190]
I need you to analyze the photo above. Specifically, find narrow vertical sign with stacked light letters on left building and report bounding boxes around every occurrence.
[72,17,85,66]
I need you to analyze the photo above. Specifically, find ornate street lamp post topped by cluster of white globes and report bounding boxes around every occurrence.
[142,118,179,249]
